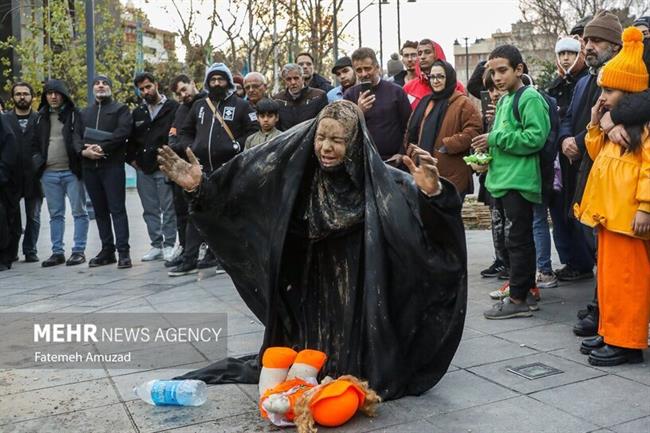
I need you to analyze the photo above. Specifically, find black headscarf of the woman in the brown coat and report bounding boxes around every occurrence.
[408,60,456,153]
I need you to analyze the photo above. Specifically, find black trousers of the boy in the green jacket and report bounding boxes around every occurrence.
[495,191,536,300]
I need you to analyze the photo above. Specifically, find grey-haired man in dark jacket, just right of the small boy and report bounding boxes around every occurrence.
[273,63,327,131]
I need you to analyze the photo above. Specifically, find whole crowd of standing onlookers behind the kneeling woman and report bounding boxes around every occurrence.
[0,12,650,365]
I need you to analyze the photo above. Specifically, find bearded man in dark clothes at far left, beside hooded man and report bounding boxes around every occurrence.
[5,82,43,263]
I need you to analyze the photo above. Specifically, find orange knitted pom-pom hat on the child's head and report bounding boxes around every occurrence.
[598,27,648,92]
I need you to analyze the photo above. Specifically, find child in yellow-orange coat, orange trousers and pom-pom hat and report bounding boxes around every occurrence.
[575,27,650,366]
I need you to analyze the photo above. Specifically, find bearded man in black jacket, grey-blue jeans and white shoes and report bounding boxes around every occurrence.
[127,72,178,262]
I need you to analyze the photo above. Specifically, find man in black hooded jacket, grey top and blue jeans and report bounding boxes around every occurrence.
[32,80,89,267]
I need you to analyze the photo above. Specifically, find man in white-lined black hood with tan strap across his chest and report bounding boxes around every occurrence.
[175,63,259,277]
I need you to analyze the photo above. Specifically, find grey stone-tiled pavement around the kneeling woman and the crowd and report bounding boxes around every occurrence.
[0,191,650,433]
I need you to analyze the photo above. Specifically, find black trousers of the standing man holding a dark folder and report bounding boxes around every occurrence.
[83,163,130,253]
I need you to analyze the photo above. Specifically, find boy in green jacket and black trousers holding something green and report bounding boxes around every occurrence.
[472,45,551,319]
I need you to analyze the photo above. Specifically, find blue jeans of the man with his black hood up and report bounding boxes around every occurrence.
[41,170,89,254]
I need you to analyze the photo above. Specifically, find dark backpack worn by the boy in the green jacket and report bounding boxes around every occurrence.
[512,86,560,204]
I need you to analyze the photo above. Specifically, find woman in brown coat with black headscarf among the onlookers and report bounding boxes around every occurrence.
[407,60,483,198]
